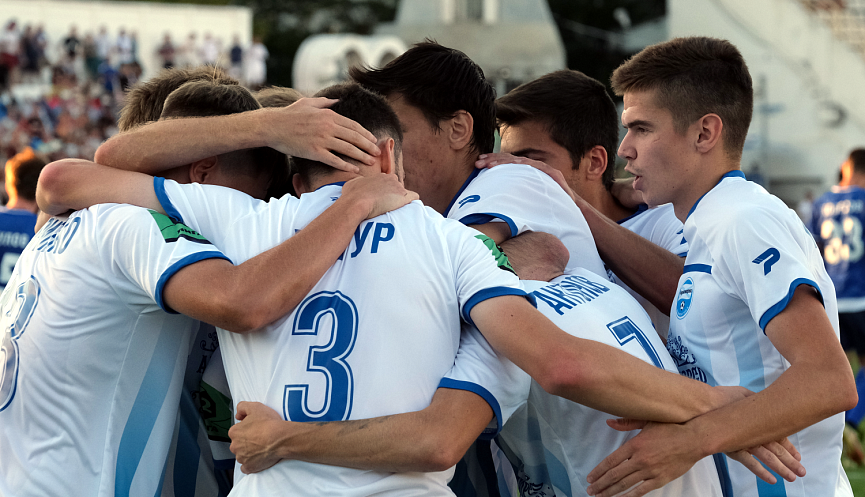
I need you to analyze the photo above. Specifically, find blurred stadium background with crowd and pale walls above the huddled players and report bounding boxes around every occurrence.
[0,0,865,490]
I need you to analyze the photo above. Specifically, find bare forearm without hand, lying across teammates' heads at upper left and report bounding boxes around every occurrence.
[95,110,267,175]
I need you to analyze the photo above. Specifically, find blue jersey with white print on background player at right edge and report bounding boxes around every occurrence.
[809,186,865,312]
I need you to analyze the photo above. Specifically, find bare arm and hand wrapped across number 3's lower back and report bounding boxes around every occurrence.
[228,388,493,473]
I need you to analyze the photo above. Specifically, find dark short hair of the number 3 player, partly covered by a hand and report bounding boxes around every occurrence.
[292,83,402,180]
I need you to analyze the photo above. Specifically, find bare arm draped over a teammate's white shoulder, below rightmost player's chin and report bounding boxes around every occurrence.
[473,154,685,314]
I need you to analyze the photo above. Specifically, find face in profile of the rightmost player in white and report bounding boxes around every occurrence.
[619,91,699,205]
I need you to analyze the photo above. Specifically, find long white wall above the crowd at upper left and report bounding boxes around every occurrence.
[0,0,252,78]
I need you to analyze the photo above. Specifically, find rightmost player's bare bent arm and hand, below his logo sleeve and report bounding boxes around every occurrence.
[589,285,857,497]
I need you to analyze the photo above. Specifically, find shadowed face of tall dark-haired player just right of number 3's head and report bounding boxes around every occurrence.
[387,93,449,200]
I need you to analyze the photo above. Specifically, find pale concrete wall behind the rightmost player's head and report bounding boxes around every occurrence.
[668,0,865,203]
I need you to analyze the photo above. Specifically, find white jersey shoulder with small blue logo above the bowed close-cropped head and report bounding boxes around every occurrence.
[445,164,607,277]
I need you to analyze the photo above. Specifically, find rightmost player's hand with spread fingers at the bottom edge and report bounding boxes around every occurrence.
[587,422,702,497]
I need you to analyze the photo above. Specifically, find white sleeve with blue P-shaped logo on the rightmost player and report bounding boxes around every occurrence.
[707,208,822,333]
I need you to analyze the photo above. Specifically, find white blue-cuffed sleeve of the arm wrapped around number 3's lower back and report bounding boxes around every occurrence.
[439,325,532,440]
